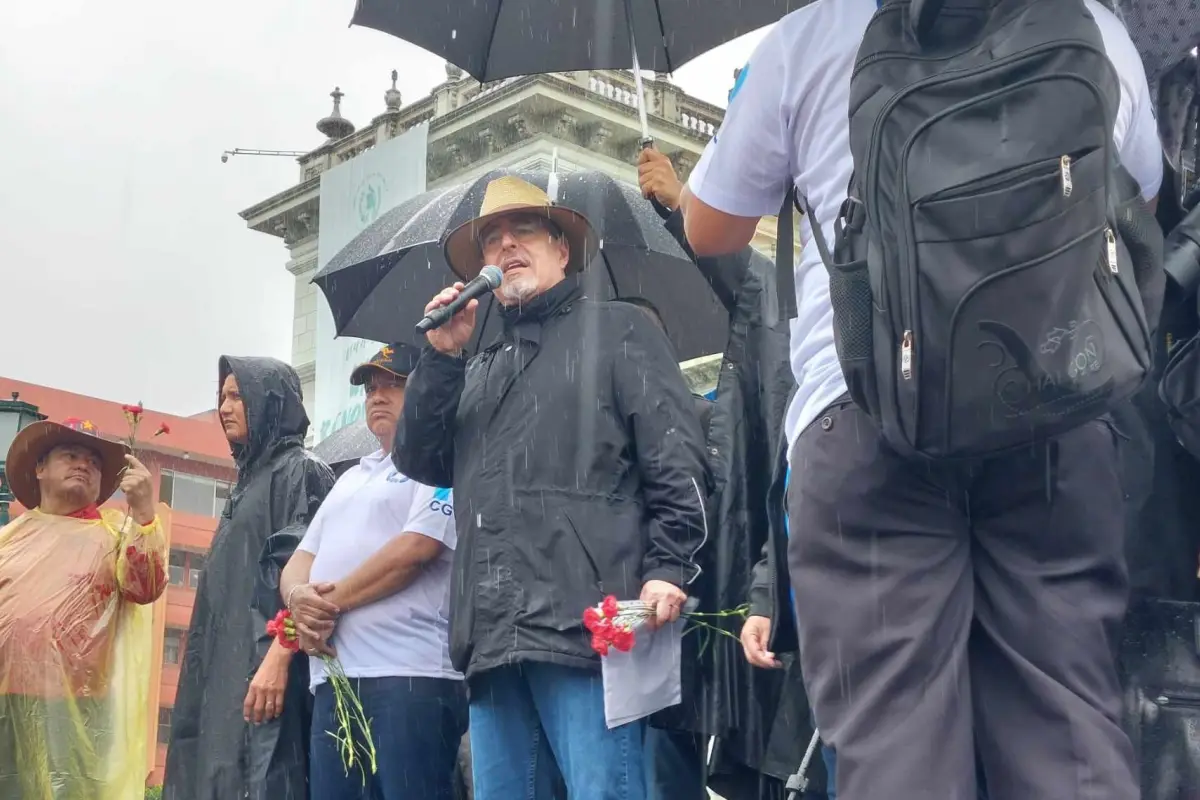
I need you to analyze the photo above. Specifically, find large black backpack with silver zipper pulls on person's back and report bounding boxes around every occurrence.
[809,0,1162,458]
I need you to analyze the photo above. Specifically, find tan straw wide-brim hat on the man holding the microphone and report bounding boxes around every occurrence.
[445,175,600,281]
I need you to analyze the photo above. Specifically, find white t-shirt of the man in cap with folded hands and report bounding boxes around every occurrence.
[300,450,462,691]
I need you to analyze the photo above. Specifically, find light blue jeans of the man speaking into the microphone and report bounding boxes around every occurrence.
[468,663,646,800]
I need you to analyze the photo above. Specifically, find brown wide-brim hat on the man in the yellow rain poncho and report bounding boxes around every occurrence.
[5,420,128,509]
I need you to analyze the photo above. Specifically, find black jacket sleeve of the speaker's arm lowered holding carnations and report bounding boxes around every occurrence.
[612,307,712,587]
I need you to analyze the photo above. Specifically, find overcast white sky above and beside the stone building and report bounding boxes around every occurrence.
[0,0,761,414]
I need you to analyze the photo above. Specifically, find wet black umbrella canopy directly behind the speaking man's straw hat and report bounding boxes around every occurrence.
[313,170,728,360]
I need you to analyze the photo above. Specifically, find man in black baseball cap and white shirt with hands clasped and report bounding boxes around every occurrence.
[280,344,467,800]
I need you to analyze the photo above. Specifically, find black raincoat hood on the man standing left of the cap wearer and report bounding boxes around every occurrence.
[218,355,308,473]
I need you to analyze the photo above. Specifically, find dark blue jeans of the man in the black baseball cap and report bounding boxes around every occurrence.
[308,678,467,800]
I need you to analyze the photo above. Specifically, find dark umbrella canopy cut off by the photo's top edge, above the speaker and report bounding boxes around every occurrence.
[350,0,796,83]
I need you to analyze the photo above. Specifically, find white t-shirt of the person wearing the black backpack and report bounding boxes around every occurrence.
[688,0,1163,453]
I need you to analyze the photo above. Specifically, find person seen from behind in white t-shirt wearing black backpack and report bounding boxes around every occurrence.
[683,0,1162,800]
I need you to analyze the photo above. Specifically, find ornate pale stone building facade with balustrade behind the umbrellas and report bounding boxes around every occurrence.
[241,65,792,416]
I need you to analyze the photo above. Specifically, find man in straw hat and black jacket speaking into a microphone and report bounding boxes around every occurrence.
[392,175,709,800]
